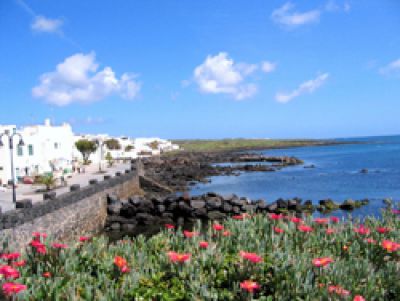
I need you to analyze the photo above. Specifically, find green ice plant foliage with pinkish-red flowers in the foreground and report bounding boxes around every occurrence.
[0,209,400,301]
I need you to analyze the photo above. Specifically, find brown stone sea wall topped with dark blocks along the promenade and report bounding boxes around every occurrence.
[0,168,140,251]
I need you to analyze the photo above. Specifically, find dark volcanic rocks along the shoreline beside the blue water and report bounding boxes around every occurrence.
[105,152,369,233]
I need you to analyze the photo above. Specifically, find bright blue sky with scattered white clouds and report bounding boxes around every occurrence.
[0,0,400,138]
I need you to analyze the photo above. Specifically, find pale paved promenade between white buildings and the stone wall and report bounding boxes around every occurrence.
[0,163,130,212]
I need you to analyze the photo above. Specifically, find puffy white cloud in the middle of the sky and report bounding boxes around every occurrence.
[193,52,258,100]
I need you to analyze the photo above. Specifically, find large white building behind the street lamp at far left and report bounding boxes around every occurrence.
[0,119,74,184]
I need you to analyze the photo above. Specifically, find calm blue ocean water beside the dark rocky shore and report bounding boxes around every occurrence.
[191,136,400,217]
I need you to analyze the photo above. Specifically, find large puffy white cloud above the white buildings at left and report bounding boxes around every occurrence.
[32,52,141,106]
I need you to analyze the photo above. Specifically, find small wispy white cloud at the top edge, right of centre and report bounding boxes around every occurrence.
[271,2,321,27]
